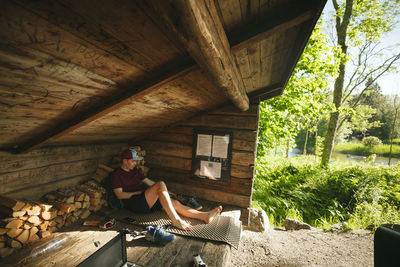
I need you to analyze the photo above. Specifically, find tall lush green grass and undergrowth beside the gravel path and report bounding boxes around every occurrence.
[253,156,400,230]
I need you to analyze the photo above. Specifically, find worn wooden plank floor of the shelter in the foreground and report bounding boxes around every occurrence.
[0,210,238,267]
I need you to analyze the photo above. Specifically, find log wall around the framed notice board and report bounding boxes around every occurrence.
[139,105,259,223]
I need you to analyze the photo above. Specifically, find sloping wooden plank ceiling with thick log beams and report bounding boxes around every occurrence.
[0,0,326,152]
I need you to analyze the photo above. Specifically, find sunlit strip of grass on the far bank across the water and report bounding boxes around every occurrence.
[333,143,400,157]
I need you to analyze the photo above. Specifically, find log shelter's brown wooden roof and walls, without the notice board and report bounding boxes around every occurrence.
[0,0,326,229]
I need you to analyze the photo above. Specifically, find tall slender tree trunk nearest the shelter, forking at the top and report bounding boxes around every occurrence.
[321,0,353,167]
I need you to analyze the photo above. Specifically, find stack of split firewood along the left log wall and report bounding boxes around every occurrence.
[0,180,107,257]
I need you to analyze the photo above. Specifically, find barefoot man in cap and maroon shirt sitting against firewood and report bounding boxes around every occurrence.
[111,149,222,230]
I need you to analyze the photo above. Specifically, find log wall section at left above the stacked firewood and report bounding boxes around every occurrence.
[0,144,127,199]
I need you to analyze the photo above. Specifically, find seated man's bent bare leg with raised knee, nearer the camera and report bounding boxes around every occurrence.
[144,182,192,230]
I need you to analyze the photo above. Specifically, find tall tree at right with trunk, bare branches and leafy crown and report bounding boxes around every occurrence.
[321,0,400,166]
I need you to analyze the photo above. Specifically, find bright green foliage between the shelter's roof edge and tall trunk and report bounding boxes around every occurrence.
[257,24,337,157]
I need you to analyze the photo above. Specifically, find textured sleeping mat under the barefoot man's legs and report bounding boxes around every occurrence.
[132,211,242,248]
